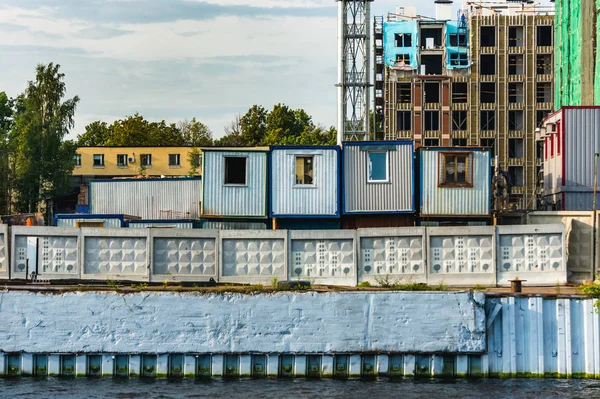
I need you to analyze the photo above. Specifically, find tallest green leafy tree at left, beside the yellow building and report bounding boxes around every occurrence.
[11,63,79,212]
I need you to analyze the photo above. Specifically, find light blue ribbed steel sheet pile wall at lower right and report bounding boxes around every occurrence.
[486,297,600,378]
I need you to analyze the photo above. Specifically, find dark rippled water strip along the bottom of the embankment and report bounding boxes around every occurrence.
[0,378,600,399]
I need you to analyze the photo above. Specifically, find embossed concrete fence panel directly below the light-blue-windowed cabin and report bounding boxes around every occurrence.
[358,227,427,284]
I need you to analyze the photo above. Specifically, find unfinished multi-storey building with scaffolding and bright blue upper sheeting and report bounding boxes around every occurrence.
[374,0,554,209]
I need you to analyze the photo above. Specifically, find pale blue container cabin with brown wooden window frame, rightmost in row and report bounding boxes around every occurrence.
[417,147,492,225]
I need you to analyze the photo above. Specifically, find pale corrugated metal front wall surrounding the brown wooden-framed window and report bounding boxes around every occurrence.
[420,149,492,216]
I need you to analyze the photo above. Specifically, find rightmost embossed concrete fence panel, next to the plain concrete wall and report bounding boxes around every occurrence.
[497,224,567,285]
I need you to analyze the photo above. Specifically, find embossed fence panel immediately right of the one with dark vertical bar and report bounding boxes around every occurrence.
[81,228,150,281]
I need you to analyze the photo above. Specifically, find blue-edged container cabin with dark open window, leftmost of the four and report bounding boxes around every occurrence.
[201,147,269,219]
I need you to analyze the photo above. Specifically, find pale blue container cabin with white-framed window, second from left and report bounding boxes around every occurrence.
[269,146,341,229]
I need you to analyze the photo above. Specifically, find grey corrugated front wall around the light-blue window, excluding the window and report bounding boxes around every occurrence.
[343,143,414,213]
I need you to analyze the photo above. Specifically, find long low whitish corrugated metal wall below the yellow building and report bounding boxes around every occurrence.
[90,179,202,219]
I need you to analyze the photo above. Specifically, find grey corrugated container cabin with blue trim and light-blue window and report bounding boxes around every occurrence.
[342,140,415,216]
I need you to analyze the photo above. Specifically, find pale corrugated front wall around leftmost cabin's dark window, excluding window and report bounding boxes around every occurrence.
[202,151,267,217]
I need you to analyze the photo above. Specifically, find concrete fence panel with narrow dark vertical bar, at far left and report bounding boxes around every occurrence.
[11,226,81,280]
